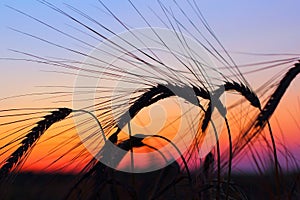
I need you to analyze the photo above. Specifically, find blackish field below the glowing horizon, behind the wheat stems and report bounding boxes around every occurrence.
[1,172,299,200]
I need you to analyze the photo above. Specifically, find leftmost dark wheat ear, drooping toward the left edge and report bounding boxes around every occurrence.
[0,108,72,179]
